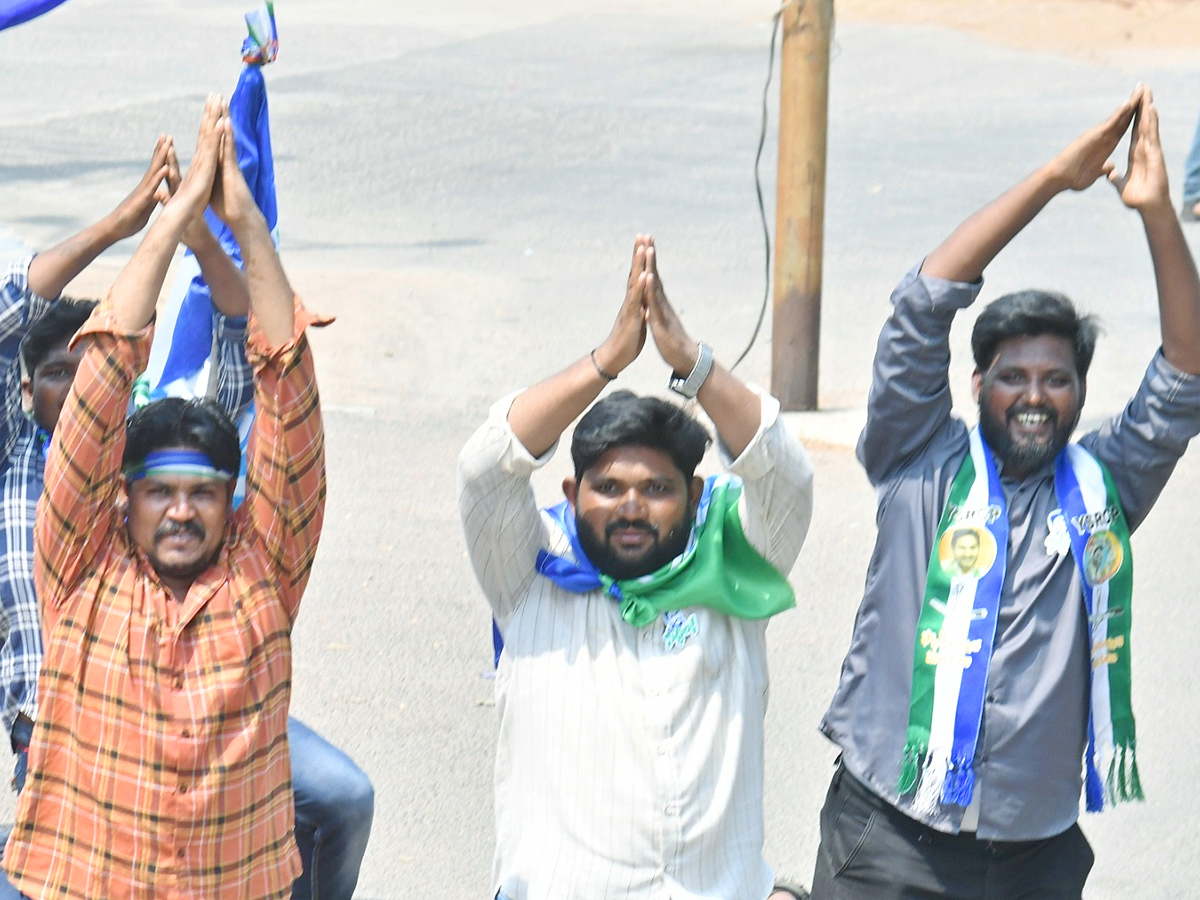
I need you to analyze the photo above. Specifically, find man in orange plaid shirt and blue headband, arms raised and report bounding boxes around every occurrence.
[4,96,325,899]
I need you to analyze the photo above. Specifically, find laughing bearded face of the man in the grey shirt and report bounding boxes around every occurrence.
[973,335,1086,479]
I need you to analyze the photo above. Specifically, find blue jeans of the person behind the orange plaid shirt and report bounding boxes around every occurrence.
[0,718,374,900]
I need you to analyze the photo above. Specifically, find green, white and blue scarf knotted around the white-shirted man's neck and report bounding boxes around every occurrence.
[538,474,796,628]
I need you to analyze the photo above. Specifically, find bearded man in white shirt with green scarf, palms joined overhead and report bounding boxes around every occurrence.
[460,236,812,900]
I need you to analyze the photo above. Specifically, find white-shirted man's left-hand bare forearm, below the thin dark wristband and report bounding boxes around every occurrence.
[509,355,616,457]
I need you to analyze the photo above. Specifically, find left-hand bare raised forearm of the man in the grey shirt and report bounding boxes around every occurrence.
[922,163,1067,282]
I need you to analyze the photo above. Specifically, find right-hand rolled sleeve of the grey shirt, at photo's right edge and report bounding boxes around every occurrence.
[1079,350,1200,530]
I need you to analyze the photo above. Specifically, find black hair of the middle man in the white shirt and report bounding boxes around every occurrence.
[571,391,710,481]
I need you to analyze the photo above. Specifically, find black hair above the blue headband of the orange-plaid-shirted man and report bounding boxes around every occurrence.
[121,397,241,474]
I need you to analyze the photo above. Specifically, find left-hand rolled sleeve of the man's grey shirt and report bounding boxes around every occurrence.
[858,264,983,486]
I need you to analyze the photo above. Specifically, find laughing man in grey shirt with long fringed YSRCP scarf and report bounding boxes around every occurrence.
[812,88,1200,900]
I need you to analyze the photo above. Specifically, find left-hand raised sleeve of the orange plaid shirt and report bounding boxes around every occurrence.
[34,299,154,634]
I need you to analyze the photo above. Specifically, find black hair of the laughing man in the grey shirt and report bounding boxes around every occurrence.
[971,290,1100,378]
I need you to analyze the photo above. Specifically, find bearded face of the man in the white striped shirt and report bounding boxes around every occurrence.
[563,445,703,578]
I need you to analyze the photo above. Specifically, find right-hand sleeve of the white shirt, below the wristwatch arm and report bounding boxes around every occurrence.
[721,384,812,576]
